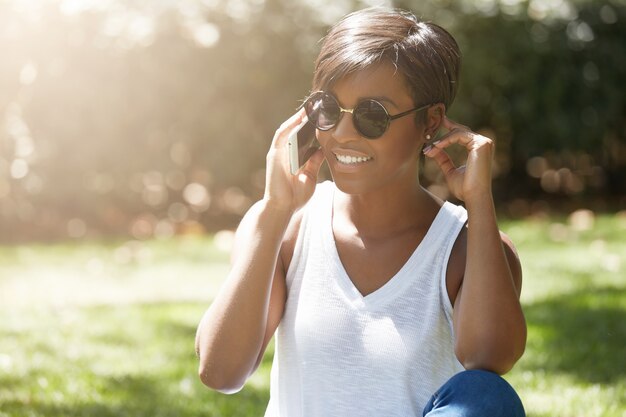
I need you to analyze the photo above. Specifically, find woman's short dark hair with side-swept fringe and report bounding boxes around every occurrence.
[313,7,461,114]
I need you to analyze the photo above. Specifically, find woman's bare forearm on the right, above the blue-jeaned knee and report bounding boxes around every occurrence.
[455,194,526,373]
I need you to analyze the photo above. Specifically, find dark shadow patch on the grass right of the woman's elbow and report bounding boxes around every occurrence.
[523,287,626,384]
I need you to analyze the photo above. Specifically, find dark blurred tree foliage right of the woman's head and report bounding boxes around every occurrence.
[424,1,626,207]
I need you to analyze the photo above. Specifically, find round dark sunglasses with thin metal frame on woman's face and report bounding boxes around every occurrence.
[304,91,430,139]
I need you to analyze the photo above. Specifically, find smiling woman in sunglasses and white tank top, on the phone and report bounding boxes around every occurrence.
[196,8,526,417]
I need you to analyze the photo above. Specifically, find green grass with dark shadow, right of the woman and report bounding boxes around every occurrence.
[502,216,626,417]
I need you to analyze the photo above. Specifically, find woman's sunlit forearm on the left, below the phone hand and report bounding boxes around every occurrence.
[196,202,291,391]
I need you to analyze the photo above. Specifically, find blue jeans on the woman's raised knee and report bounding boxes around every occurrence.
[423,370,526,417]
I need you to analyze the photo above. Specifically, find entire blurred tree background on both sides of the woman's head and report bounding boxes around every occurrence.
[0,0,626,241]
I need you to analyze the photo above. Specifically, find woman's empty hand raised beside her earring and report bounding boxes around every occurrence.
[424,116,495,203]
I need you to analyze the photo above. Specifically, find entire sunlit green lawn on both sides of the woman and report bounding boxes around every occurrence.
[0,216,626,417]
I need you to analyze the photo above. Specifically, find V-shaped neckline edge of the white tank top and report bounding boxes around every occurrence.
[323,187,450,308]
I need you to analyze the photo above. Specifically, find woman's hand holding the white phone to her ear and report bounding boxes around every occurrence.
[263,109,324,213]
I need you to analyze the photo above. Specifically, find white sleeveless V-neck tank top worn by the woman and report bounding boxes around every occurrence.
[265,182,467,417]
